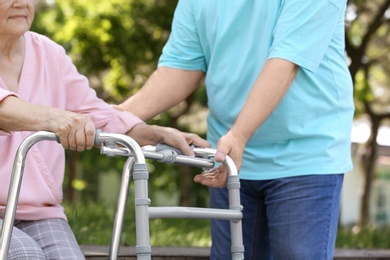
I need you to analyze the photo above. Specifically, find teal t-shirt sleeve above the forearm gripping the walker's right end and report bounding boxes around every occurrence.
[269,0,345,72]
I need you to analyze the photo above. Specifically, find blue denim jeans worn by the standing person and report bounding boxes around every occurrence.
[210,174,344,260]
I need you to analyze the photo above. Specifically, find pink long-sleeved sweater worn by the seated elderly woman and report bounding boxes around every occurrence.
[0,32,142,220]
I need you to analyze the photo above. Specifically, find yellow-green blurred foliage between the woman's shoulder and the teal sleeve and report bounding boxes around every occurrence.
[32,0,177,102]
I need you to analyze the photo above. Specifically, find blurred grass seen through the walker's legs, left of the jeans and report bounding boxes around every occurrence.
[64,198,211,247]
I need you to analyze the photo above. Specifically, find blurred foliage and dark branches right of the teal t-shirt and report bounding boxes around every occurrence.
[346,0,390,116]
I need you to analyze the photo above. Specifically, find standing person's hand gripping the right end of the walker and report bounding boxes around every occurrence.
[194,132,246,188]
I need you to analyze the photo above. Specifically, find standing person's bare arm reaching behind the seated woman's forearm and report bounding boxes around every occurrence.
[119,67,204,121]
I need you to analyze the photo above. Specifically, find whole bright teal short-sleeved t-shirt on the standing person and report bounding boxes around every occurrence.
[159,0,354,180]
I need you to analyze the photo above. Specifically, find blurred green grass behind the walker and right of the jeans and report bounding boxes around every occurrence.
[64,200,390,249]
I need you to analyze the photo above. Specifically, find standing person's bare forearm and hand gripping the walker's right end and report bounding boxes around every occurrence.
[194,58,299,188]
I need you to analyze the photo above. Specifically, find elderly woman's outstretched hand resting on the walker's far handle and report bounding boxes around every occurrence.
[127,124,210,156]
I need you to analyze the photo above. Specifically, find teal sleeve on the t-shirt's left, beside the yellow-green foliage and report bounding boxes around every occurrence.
[158,0,206,72]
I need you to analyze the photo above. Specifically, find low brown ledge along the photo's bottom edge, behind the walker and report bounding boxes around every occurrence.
[81,246,390,260]
